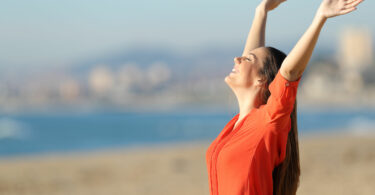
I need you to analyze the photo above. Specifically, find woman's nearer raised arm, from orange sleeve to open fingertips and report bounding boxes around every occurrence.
[280,0,363,81]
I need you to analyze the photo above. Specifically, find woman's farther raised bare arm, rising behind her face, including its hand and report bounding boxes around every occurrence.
[242,0,286,56]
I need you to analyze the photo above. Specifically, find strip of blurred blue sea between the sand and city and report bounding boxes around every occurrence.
[0,110,375,157]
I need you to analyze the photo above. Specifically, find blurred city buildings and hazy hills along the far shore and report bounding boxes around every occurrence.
[0,27,375,113]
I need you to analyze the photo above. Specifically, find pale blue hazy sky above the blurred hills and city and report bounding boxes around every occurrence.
[0,0,375,67]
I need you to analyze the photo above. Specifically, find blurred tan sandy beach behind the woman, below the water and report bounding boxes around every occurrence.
[0,134,375,195]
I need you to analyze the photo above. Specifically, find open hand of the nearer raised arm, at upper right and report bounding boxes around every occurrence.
[318,0,363,18]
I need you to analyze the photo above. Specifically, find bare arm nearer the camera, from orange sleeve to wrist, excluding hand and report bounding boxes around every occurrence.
[280,14,327,81]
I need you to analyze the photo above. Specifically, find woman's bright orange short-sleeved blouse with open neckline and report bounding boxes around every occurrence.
[206,71,301,195]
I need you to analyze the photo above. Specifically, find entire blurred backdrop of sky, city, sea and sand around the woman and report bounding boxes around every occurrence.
[0,0,375,194]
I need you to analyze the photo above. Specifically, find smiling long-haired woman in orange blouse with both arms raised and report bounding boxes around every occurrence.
[206,0,363,195]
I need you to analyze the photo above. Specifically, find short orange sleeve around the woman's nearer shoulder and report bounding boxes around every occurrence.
[264,70,302,120]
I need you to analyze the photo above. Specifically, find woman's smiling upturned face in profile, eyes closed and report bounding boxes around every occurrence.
[225,47,267,89]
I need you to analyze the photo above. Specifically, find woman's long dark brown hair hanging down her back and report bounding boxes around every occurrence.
[259,47,301,195]
